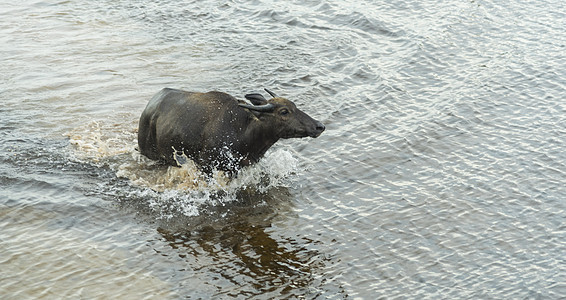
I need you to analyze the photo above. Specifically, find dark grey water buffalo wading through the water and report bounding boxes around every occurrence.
[138,88,325,173]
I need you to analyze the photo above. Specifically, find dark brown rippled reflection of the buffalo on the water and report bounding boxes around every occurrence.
[159,191,324,298]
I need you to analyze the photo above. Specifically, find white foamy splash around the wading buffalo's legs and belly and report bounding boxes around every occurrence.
[66,121,298,218]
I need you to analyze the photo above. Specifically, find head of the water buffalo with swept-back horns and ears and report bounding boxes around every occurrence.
[239,89,325,139]
